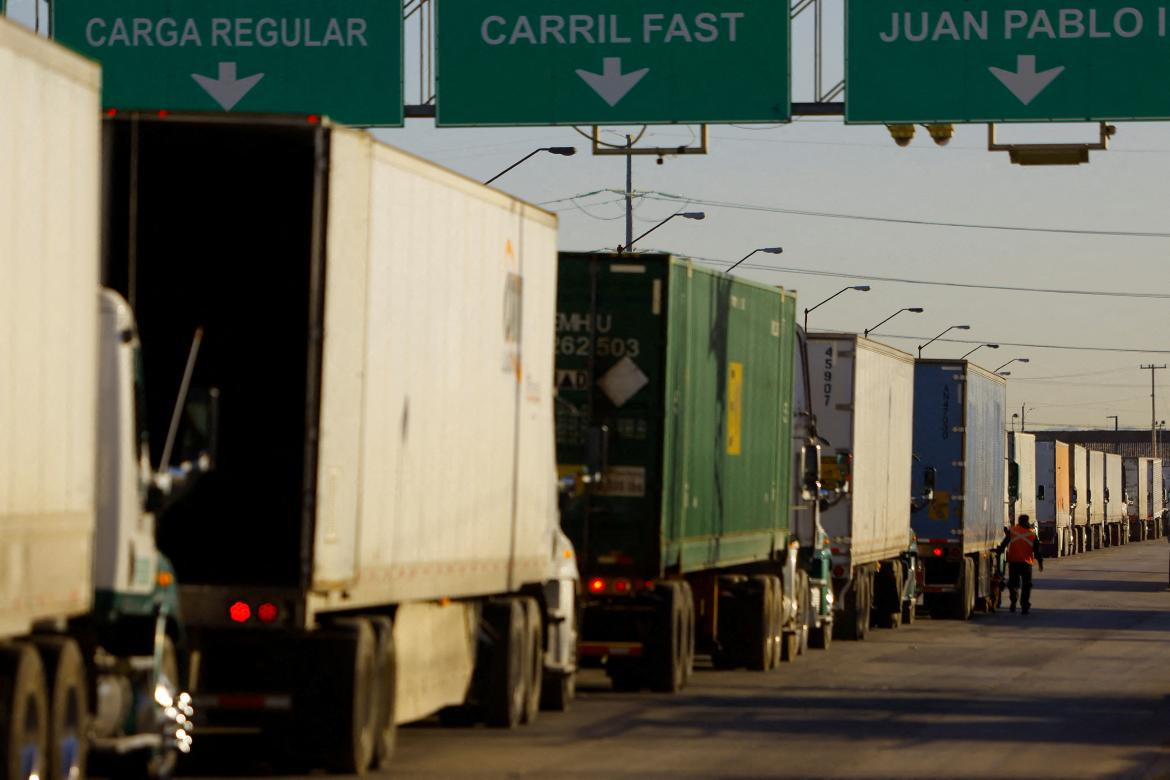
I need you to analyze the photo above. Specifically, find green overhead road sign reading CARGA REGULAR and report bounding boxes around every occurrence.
[51,0,402,125]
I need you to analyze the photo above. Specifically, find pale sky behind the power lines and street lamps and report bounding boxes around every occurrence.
[9,0,1170,428]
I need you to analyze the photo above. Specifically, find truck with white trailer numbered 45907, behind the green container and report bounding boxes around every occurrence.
[808,333,918,640]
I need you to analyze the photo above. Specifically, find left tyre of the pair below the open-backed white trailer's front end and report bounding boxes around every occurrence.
[483,599,528,729]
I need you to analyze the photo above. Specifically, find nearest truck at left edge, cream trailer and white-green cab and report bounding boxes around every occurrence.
[0,19,204,780]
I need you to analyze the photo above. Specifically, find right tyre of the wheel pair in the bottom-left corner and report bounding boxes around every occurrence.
[33,636,89,780]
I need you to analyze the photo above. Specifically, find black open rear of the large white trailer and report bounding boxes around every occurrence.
[103,117,328,587]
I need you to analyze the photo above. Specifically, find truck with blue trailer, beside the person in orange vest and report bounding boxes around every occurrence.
[911,359,1014,620]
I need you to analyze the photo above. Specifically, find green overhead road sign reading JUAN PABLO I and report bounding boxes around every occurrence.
[845,0,1170,124]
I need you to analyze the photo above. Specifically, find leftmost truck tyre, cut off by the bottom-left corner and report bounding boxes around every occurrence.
[0,643,49,780]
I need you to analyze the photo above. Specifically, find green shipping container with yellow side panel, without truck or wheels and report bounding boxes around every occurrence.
[556,253,796,578]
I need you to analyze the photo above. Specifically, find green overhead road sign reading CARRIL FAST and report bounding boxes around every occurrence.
[435,0,790,126]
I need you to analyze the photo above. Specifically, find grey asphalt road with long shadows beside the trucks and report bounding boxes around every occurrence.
[182,540,1170,779]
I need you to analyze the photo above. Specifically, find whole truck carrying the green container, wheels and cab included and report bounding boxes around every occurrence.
[556,253,833,692]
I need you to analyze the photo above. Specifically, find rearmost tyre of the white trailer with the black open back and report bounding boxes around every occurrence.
[314,617,381,774]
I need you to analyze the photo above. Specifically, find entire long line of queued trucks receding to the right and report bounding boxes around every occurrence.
[0,19,1162,780]
